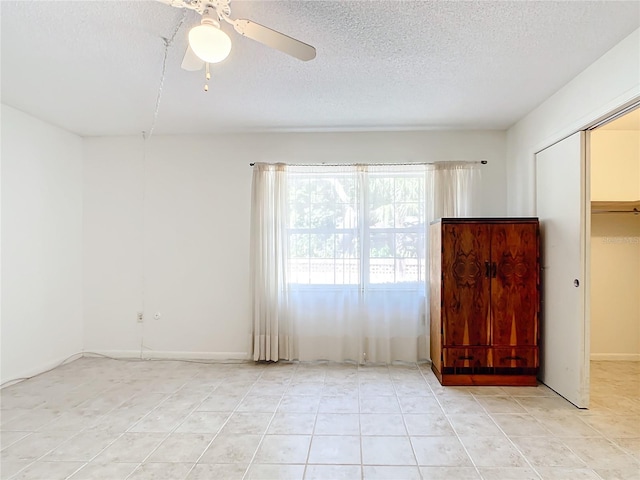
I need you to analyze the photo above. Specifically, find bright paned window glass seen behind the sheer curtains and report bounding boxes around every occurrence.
[286,166,425,288]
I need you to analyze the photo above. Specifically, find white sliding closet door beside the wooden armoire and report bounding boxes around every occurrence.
[536,132,590,408]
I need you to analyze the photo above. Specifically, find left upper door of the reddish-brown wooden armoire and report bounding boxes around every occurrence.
[442,222,491,346]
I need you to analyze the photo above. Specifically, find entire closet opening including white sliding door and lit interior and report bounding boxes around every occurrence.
[535,103,640,408]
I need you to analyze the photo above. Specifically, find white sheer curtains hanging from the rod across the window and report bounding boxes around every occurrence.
[251,163,479,362]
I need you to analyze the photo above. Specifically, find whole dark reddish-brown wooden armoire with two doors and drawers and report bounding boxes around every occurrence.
[429,218,540,385]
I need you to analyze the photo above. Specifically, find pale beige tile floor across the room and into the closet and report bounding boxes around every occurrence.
[0,358,640,480]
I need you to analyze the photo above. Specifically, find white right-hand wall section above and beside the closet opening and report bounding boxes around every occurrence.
[507,29,640,215]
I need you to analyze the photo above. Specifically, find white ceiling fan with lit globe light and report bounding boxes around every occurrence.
[158,0,316,71]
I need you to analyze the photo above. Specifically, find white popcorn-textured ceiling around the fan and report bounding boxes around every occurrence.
[0,0,640,135]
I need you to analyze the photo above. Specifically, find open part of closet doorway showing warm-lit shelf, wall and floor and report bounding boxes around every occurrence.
[587,108,640,408]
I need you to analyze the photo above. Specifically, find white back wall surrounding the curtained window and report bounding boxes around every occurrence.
[84,131,506,358]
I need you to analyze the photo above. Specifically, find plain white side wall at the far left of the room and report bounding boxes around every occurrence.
[0,105,83,382]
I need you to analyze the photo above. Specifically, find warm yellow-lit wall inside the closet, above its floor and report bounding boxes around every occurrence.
[590,124,640,361]
